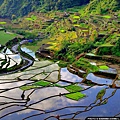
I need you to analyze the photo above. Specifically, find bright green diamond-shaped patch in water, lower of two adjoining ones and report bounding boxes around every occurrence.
[65,92,86,101]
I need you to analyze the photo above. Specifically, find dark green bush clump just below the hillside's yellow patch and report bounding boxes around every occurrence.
[55,41,94,63]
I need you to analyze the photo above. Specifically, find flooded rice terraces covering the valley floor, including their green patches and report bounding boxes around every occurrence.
[0,36,120,120]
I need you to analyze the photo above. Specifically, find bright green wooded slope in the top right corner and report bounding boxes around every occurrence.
[77,0,120,16]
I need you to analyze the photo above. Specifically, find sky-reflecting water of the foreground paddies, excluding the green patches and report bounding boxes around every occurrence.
[0,48,120,120]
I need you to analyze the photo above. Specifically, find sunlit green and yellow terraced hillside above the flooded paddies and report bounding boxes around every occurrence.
[0,0,120,58]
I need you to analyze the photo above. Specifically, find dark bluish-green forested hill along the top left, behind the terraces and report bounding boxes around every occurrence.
[0,0,90,17]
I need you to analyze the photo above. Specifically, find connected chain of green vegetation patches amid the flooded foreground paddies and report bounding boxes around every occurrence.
[20,80,86,101]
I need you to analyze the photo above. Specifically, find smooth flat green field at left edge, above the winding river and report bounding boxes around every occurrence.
[0,31,17,45]
